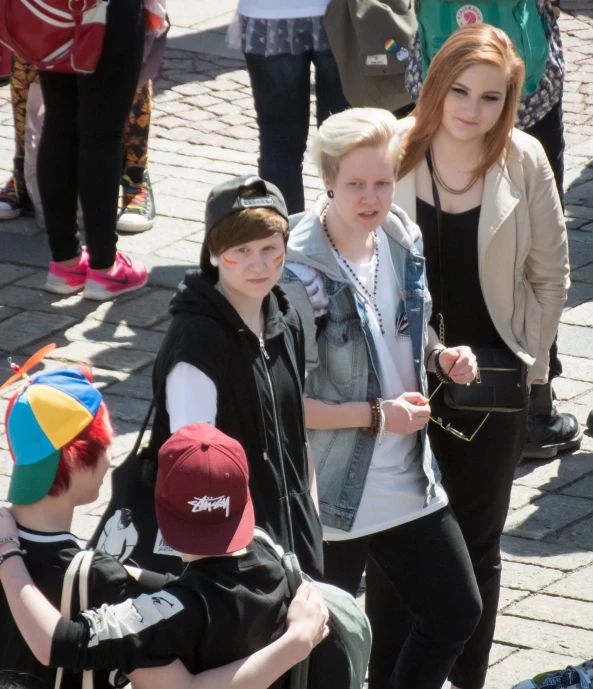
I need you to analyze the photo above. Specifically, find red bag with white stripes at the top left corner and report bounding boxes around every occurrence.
[0,0,109,74]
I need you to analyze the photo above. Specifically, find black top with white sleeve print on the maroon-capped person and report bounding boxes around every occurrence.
[51,540,290,689]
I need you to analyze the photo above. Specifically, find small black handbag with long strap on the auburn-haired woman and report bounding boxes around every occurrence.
[426,152,528,412]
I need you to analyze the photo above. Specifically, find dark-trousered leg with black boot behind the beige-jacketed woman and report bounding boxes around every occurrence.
[523,103,583,459]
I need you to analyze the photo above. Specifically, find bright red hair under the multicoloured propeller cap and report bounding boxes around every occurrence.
[48,366,113,496]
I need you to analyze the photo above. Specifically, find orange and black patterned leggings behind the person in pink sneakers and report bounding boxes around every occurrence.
[10,55,152,170]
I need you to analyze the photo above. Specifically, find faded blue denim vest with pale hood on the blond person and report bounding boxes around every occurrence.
[282,199,440,531]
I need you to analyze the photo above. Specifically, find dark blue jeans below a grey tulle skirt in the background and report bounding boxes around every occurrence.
[245,51,349,213]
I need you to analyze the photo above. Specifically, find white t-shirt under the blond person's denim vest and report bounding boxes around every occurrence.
[323,227,448,541]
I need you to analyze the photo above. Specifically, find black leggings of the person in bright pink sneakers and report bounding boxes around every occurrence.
[37,0,144,269]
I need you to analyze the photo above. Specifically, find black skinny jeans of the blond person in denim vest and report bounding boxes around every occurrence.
[323,506,482,689]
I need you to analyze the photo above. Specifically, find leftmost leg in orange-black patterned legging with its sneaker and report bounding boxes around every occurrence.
[0,55,39,220]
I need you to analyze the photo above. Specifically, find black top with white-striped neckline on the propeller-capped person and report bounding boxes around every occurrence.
[0,527,168,689]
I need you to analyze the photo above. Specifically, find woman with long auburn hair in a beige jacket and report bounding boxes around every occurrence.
[388,25,569,689]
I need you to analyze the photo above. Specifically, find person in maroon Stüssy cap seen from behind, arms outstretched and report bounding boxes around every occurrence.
[0,422,329,689]
